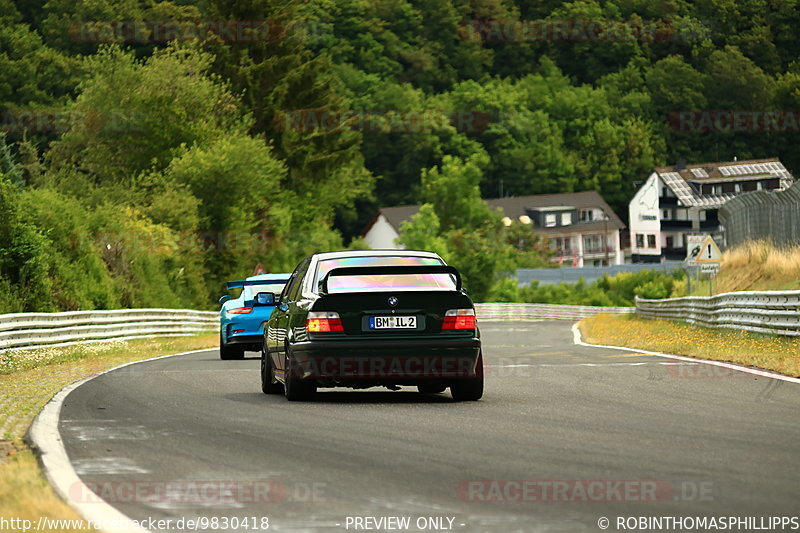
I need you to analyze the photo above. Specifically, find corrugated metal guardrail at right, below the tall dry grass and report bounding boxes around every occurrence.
[636,291,800,336]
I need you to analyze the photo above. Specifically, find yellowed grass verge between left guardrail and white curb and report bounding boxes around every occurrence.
[0,333,218,524]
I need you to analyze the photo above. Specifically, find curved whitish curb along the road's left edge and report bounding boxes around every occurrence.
[26,348,216,533]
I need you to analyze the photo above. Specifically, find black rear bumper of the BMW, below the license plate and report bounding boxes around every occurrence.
[290,337,481,384]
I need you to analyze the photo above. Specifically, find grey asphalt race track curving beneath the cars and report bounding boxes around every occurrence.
[60,322,800,532]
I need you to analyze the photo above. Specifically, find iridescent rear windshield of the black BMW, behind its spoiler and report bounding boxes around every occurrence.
[316,255,456,293]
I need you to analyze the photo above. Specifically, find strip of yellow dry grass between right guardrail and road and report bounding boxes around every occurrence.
[579,314,800,379]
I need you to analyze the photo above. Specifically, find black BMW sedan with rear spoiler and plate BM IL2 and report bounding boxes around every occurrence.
[261,250,483,401]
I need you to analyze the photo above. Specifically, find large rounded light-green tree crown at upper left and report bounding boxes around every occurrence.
[48,46,247,187]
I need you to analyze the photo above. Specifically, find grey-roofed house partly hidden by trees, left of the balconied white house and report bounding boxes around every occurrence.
[363,191,625,266]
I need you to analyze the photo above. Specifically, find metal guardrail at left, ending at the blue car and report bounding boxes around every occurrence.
[0,309,219,351]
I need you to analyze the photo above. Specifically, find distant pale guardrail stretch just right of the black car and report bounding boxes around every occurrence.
[475,303,636,321]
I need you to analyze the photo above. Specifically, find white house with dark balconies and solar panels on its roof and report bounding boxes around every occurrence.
[628,158,794,263]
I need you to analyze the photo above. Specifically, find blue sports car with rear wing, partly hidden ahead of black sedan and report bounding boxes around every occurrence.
[219,274,291,359]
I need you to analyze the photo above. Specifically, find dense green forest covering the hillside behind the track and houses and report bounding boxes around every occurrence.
[0,0,800,313]
